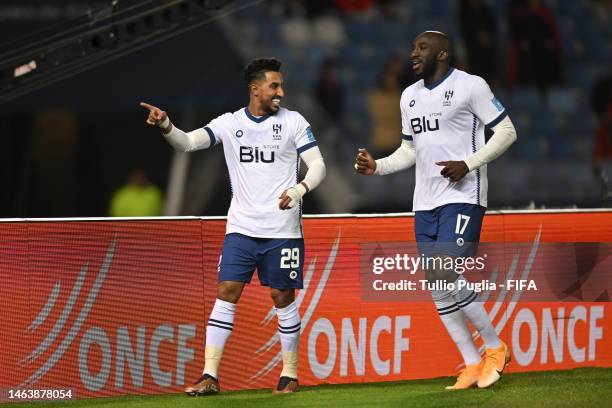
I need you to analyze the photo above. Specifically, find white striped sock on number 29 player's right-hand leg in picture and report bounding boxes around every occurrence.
[276,302,302,378]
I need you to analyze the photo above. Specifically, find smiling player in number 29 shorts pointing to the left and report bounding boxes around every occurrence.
[141,58,325,396]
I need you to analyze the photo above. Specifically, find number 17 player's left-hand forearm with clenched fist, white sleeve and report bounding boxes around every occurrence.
[355,140,416,176]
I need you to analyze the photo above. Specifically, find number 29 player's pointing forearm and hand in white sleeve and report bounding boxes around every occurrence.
[140,102,211,152]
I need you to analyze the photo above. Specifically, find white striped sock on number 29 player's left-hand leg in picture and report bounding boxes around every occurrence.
[203,299,236,378]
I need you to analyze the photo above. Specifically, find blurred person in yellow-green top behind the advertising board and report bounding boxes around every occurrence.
[109,169,163,217]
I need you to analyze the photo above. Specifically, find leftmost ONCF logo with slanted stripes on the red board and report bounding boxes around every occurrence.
[19,239,197,391]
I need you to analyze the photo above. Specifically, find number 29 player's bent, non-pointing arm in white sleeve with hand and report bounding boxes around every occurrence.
[278,146,326,210]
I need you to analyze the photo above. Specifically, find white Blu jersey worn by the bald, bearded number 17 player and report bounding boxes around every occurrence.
[400,68,507,211]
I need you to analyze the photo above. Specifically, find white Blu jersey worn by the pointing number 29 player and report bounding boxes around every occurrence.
[204,108,317,238]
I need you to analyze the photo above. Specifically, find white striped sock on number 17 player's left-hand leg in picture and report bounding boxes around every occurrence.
[431,290,480,365]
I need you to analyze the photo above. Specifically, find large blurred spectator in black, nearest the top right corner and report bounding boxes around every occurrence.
[508,0,563,96]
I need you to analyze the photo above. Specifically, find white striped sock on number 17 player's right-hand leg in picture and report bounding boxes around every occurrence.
[453,276,501,348]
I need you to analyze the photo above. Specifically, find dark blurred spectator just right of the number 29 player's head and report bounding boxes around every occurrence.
[315,58,344,122]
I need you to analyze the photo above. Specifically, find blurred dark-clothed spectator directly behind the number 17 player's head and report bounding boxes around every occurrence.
[459,0,499,83]
